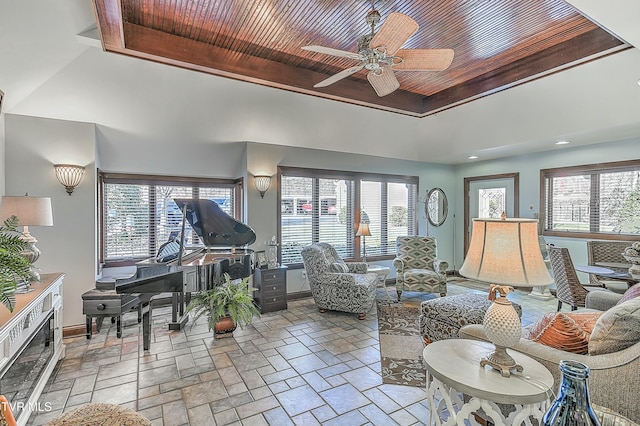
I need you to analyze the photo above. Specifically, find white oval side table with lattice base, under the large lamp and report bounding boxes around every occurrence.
[422,339,553,426]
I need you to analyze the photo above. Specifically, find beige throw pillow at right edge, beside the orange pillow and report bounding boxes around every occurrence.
[589,297,640,355]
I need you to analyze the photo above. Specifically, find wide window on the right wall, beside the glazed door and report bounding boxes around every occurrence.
[541,160,640,239]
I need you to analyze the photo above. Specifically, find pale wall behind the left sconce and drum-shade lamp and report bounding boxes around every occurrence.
[5,114,97,325]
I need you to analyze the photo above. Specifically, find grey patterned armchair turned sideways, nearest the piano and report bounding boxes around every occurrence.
[301,243,378,320]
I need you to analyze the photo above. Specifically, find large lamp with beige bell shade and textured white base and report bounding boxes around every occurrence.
[460,218,553,377]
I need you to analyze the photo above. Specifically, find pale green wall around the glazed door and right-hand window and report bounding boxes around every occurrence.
[455,139,640,269]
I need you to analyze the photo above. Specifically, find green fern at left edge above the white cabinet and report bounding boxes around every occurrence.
[0,216,31,312]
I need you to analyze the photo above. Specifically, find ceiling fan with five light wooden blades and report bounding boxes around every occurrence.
[303,7,453,97]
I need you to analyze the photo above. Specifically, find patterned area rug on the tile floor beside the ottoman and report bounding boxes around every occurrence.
[376,293,435,387]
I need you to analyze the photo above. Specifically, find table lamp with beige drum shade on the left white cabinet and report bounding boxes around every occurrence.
[0,194,53,279]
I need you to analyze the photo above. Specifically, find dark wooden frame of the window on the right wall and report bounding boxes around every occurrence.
[538,159,640,241]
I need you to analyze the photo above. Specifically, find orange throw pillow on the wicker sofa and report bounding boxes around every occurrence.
[525,312,603,355]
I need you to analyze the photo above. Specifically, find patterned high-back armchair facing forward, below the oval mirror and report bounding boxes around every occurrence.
[393,235,449,300]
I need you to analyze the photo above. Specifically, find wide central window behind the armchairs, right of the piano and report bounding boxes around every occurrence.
[278,167,418,265]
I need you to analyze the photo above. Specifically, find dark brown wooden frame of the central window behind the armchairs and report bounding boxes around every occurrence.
[276,166,420,269]
